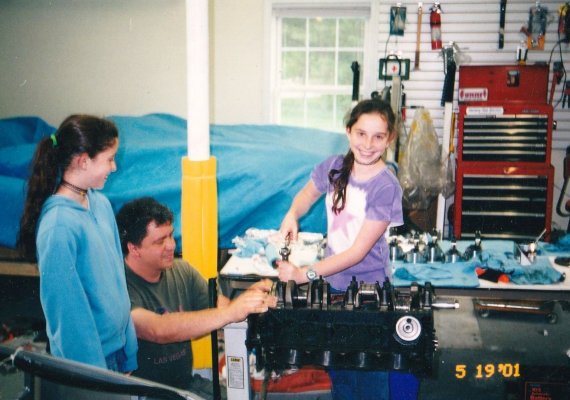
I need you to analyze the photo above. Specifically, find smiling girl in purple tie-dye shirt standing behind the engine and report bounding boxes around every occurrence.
[278,99,418,400]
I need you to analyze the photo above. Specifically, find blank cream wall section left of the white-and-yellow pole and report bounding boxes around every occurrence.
[0,0,186,125]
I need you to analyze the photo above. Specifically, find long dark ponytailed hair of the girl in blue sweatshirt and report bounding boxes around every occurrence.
[16,114,119,261]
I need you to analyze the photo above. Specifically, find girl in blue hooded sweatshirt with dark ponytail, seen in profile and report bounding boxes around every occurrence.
[18,115,137,372]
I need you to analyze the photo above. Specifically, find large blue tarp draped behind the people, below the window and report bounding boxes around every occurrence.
[0,114,348,249]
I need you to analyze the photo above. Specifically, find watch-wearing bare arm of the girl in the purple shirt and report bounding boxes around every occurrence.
[278,219,389,283]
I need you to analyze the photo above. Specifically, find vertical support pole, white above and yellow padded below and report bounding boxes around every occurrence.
[181,0,218,373]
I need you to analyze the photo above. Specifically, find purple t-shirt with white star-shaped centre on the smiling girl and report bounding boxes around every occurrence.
[311,155,404,290]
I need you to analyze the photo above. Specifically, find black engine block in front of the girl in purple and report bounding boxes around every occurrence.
[246,277,437,376]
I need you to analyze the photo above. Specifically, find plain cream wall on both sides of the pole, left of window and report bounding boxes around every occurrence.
[0,0,266,125]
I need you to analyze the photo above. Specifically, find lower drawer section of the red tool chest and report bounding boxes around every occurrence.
[454,166,554,240]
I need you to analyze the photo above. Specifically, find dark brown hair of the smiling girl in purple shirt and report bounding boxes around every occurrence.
[329,99,396,214]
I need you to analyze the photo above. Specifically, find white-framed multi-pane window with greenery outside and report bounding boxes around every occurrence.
[272,2,370,132]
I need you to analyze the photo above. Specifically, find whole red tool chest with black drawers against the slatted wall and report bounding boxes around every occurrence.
[453,65,554,240]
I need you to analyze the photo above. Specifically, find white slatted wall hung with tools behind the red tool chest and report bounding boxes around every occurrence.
[372,0,570,229]
